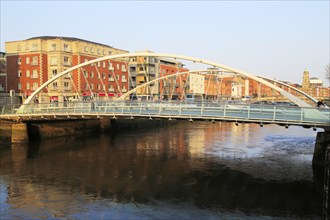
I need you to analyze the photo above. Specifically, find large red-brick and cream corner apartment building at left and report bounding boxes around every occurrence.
[5,36,128,102]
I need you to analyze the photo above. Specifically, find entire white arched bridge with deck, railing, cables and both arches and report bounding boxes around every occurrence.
[0,52,330,129]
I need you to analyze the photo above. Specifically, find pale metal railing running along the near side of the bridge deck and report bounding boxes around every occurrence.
[1,101,330,125]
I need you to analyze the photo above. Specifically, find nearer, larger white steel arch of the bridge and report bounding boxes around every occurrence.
[20,52,311,109]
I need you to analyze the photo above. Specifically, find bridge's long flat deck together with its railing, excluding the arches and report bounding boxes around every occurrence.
[1,100,330,129]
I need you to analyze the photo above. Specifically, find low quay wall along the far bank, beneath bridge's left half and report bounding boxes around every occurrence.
[0,118,170,144]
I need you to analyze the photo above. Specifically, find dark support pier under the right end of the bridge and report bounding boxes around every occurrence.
[312,131,330,172]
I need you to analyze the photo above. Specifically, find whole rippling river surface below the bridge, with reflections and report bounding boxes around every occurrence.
[0,122,323,219]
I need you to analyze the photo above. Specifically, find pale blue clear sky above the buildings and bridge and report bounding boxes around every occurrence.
[0,0,330,85]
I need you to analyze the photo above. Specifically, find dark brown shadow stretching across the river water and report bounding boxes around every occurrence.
[0,122,322,218]
